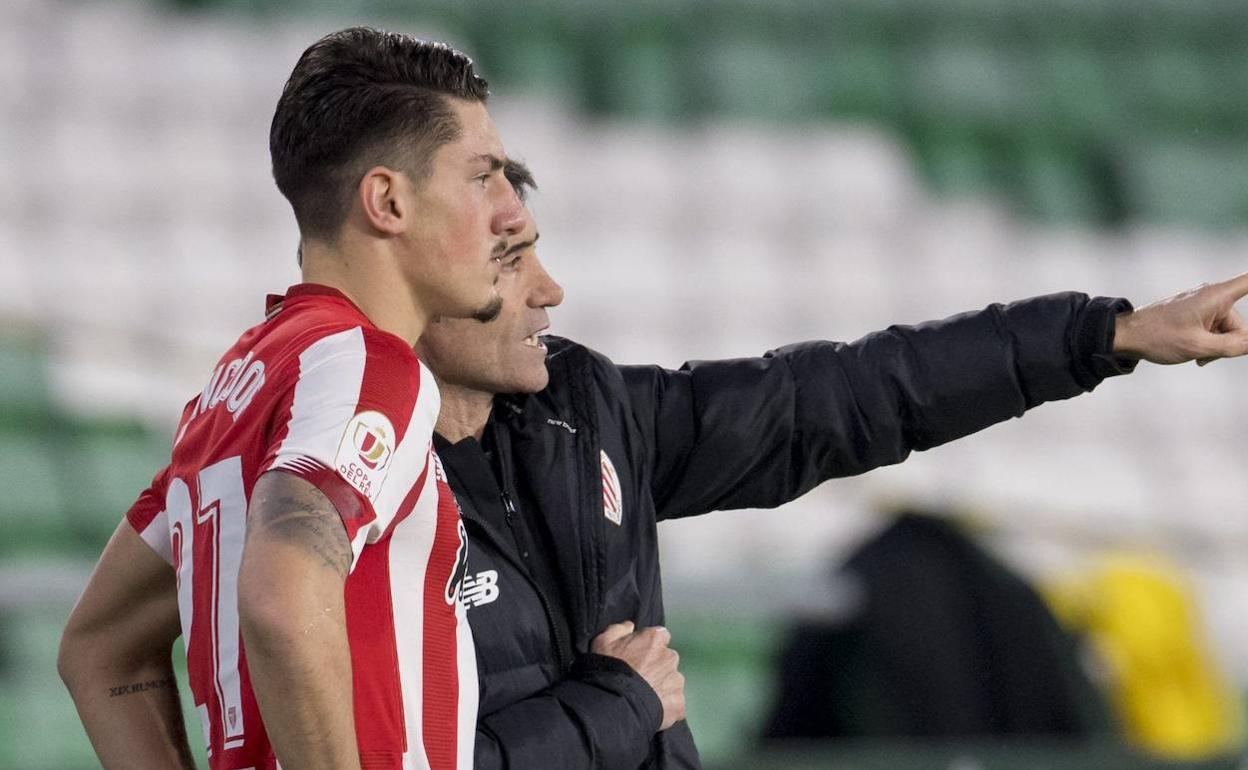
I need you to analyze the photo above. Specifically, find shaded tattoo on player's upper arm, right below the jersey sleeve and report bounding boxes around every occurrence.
[247,474,351,578]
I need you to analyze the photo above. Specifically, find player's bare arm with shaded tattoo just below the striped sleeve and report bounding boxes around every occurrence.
[238,470,359,770]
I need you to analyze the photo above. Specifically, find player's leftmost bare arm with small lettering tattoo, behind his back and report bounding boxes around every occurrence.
[56,520,195,770]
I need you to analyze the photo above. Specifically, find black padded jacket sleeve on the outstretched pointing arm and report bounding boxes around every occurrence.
[620,293,1133,518]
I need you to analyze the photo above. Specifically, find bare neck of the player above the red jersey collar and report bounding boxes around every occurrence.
[302,238,429,346]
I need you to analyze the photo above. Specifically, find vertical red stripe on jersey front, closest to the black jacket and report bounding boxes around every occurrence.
[422,479,466,770]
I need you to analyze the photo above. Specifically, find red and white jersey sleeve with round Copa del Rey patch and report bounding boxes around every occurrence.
[260,327,438,559]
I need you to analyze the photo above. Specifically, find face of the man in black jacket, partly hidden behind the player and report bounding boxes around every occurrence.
[416,210,563,393]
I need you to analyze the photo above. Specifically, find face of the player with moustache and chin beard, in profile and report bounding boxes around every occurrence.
[403,99,525,318]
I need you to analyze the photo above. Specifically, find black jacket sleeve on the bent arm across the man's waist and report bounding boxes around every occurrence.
[474,654,663,770]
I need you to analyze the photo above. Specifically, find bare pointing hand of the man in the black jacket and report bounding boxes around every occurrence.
[1113,273,1248,366]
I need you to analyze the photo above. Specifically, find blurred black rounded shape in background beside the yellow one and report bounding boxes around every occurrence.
[764,515,1109,739]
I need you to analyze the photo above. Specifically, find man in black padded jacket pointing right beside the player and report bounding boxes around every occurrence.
[418,159,1248,770]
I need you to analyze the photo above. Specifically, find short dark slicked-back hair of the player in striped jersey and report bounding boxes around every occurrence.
[268,26,489,238]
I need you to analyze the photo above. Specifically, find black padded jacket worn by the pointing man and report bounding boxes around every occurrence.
[439,293,1129,770]
